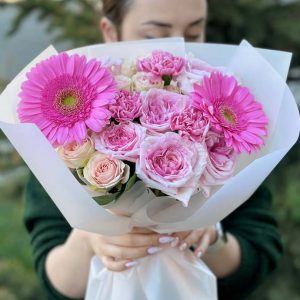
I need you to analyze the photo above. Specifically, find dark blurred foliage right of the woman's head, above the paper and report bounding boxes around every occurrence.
[207,0,300,71]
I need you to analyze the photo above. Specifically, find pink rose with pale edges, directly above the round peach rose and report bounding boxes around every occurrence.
[94,122,146,162]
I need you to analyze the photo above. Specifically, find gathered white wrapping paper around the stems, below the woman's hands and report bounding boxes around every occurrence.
[86,249,217,300]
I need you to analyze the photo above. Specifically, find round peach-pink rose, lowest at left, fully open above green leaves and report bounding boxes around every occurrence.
[83,152,130,192]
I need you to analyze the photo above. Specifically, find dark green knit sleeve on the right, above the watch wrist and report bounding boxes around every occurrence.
[218,186,283,300]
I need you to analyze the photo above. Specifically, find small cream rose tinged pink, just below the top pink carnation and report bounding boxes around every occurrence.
[132,72,164,92]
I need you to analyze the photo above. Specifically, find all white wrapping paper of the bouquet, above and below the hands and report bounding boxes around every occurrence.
[0,39,300,300]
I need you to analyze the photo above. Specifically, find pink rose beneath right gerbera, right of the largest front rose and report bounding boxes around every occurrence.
[200,133,237,197]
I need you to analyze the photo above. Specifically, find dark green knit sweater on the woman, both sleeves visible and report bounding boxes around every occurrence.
[25,176,282,300]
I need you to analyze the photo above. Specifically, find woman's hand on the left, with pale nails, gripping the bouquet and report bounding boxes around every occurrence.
[85,228,176,271]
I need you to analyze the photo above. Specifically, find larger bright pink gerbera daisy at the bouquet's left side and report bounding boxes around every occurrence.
[18,53,116,145]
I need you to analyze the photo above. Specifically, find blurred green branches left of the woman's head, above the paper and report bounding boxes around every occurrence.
[8,0,101,46]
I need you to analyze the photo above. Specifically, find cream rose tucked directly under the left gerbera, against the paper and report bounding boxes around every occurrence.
[57,137,95,169]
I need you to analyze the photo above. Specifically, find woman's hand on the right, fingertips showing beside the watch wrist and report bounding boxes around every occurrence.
[172,226,217,258]
